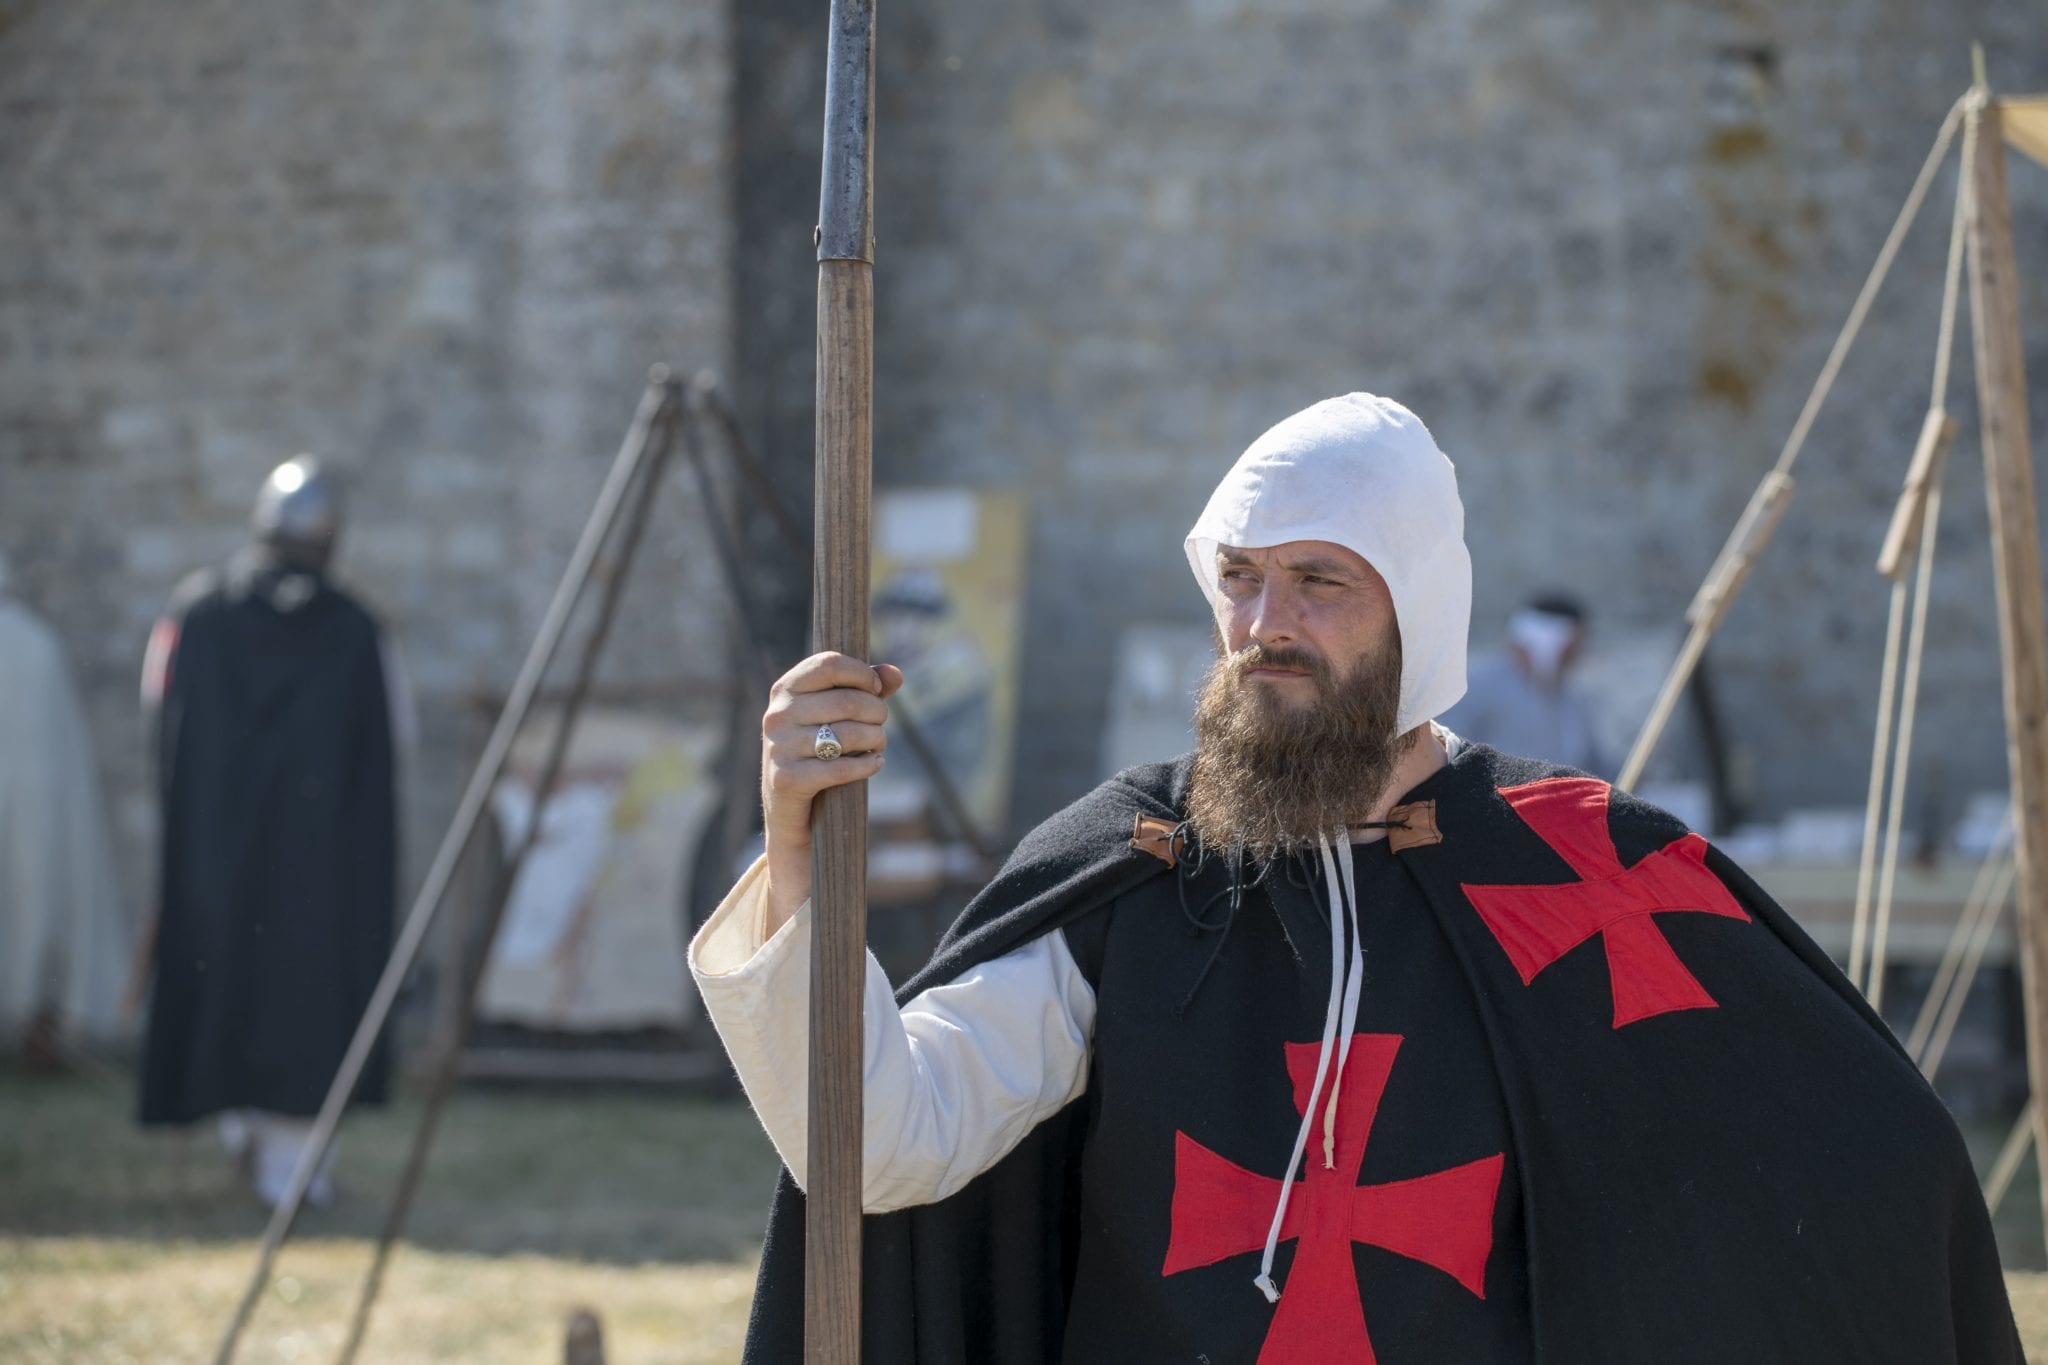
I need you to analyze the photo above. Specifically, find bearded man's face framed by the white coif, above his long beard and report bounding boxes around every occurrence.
[1217,540,1397,706]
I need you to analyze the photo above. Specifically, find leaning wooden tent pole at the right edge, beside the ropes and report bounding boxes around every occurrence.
[1964,86,2048,1252]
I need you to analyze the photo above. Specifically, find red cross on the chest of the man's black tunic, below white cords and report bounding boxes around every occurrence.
[1163,1033,1501,1365]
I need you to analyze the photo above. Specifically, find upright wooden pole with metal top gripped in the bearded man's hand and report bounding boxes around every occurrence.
[803,0,874,1365]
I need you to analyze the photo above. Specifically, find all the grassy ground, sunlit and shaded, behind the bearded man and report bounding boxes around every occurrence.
[12,1068,2048,1365]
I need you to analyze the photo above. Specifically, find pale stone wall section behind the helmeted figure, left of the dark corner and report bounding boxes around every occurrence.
[0,0,733,916]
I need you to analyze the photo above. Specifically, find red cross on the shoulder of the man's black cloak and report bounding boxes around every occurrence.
[1464,778,1749,1027]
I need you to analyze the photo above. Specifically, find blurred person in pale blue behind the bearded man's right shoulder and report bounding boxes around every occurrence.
[1444,593,1614,778]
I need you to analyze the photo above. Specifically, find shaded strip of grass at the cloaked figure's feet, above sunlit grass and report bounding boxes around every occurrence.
[0,1068,776,1265]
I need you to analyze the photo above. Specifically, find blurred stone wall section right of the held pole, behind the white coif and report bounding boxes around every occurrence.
[847,0,2048,834]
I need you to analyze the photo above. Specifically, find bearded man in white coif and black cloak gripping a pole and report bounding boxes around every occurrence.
[692,393,2021,1365]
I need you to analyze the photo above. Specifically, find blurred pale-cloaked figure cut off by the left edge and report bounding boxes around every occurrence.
[0,555,131,1070]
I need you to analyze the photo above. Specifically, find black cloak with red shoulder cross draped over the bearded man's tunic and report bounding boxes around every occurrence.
[745,745,2021,1365]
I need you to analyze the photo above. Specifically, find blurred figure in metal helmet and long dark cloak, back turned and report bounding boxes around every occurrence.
[141,456,410,1205]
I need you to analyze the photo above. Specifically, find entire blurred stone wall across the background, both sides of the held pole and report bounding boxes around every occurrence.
[0,0,2048,933]
